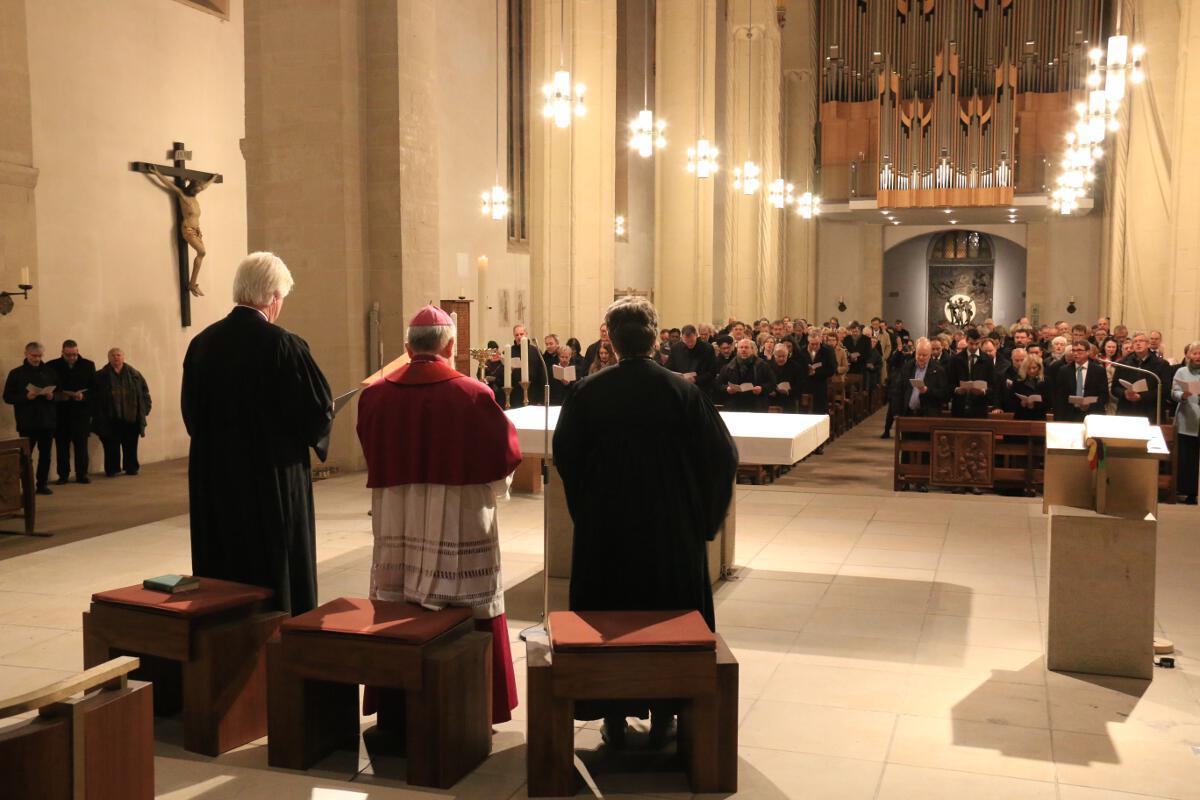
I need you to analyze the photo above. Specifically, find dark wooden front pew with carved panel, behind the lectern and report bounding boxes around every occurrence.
[892,414,1178,503]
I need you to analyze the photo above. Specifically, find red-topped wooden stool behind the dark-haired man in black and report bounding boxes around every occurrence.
[526,612,738,798]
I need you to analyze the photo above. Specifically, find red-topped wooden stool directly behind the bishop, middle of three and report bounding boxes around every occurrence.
[266,597,492,789]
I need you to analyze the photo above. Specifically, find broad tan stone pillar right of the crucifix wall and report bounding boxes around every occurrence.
[244,0,439,468]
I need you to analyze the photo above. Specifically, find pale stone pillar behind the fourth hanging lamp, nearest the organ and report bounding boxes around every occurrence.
[719,0,784,319]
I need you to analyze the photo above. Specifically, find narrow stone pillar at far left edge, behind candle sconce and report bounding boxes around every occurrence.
[0,0,40,438]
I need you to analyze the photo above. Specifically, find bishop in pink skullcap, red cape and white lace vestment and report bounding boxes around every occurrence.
[358,306,523,723]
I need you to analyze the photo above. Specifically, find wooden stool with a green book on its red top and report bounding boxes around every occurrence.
[83,578,287,756]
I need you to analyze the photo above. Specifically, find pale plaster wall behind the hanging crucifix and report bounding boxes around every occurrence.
[26,0,246,462]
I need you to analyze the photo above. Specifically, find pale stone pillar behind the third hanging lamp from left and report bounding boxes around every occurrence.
[654,0,710,326]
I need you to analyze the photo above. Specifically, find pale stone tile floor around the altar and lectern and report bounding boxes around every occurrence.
[0,450,1200,800]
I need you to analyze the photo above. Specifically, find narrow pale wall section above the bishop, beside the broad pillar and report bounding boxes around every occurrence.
[432,0,525,345]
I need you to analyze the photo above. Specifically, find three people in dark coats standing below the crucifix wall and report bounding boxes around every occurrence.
[4,339,151,494]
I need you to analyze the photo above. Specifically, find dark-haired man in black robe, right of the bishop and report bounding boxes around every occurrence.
[553,297,739,745]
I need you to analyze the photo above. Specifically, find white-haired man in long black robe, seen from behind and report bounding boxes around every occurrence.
[182,253,334,614]
